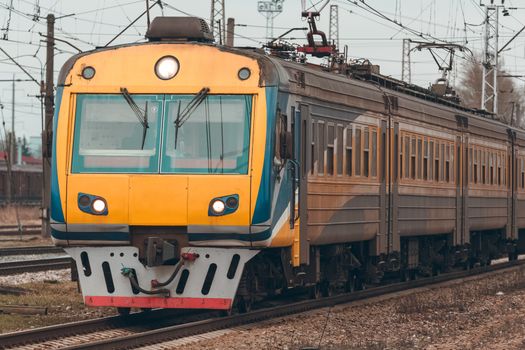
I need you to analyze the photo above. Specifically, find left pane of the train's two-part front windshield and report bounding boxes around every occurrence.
[72,94,162,172]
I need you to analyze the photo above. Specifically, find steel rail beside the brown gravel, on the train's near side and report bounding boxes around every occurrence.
[15,261,525,350]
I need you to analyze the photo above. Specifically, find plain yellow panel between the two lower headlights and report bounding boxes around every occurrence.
[129,175,188,226]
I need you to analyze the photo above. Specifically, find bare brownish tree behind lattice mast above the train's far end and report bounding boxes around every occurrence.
[456,57,525,127]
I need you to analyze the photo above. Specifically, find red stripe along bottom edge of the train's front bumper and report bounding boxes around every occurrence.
[84,296,232,310]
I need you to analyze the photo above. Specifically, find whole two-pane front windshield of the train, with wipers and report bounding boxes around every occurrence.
[72,94,252,174]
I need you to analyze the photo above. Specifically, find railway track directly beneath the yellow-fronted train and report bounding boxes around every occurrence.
[0,261,525,350]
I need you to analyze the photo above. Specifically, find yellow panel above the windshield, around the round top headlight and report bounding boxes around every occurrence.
[69,44,259,94]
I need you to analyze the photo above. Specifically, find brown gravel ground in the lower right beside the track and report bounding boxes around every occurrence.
[169,268,525,349]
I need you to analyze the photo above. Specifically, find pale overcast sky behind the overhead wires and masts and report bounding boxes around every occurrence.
[0,0,525,137]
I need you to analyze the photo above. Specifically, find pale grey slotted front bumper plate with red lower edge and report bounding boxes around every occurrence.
[65,246,259,310]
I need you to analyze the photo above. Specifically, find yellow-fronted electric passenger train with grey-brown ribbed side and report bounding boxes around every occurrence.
[51,17,525,312]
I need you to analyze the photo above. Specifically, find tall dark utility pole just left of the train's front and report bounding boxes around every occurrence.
[42,14,55,236]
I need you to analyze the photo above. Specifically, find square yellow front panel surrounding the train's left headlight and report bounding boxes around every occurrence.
[66,174,128,224]
